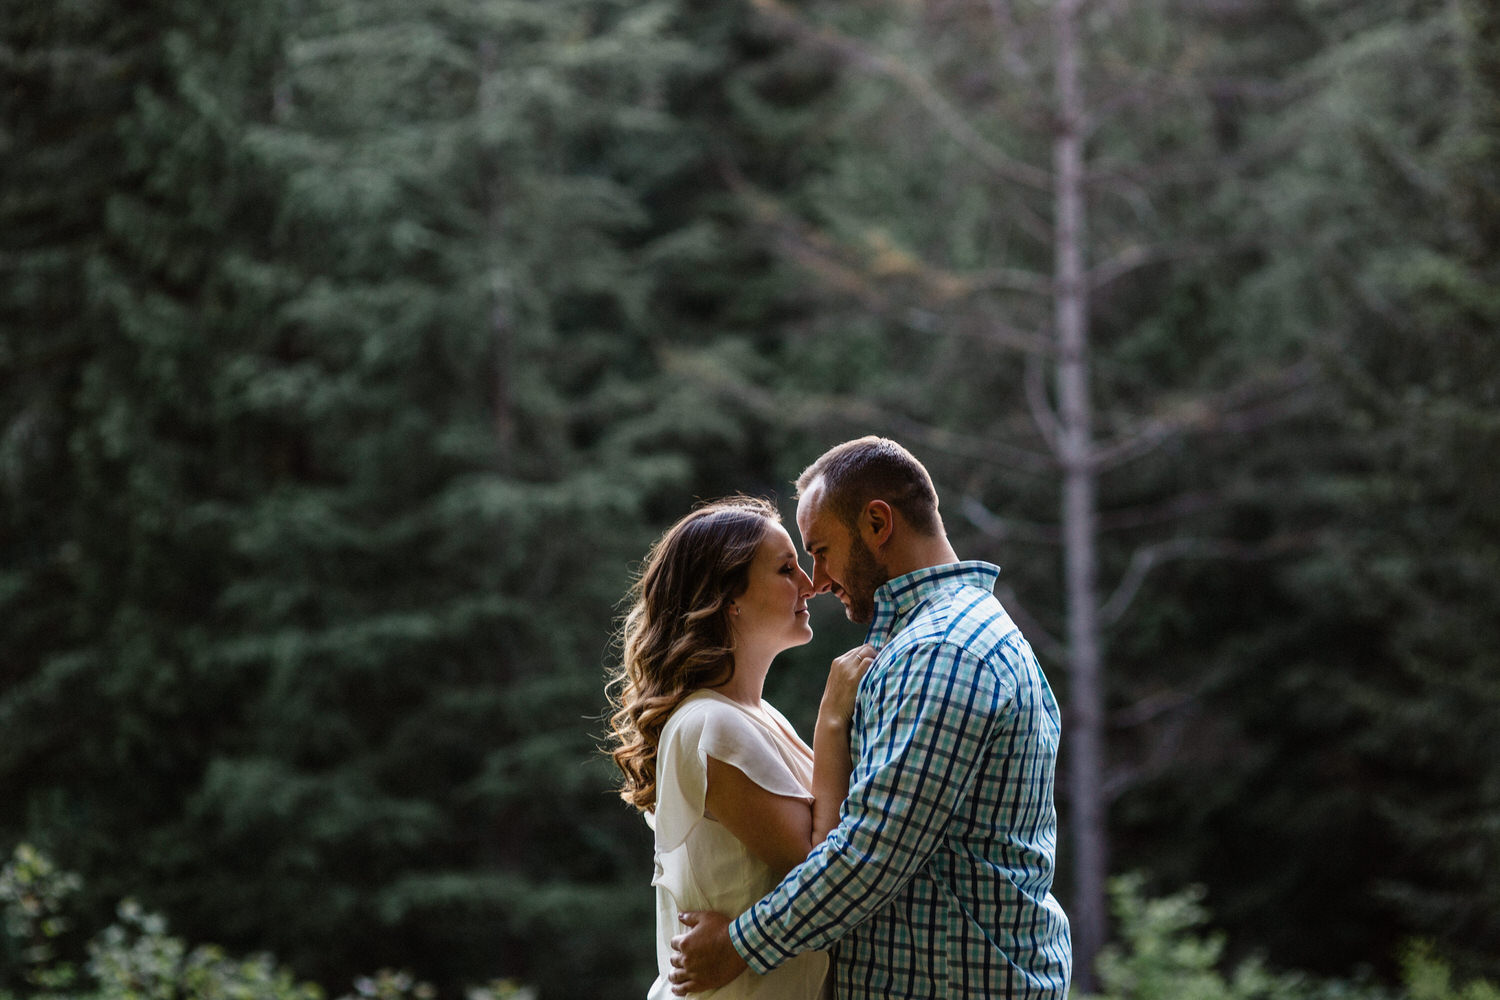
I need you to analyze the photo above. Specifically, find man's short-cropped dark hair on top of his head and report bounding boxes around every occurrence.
[797,435,942,535]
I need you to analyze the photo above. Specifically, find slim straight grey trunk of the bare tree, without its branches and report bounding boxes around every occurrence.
[1053,0,1107,990]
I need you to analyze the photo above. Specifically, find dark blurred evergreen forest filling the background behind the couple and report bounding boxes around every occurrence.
[0,0,1500,999]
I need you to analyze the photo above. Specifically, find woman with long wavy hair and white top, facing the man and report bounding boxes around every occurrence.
[611,498,875,1000]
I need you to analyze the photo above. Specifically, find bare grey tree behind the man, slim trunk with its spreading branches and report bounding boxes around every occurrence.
[735,0,1310,991]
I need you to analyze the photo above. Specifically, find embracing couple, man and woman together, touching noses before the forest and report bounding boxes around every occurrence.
[612,438,1071,1000]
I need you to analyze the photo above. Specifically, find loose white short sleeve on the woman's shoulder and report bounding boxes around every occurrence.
[656,699,813,850]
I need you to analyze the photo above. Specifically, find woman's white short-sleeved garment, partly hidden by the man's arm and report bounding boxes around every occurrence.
[647,688,828,1000]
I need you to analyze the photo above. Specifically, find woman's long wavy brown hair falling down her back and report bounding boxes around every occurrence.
[609,496,782,811]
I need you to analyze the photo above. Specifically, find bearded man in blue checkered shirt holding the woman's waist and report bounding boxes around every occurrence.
[669,438,1073,1000]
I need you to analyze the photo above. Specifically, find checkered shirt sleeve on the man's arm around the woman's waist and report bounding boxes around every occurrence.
[729,642,1014,973]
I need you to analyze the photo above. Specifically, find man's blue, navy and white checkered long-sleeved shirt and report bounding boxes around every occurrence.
[729,562,1073,1000]
